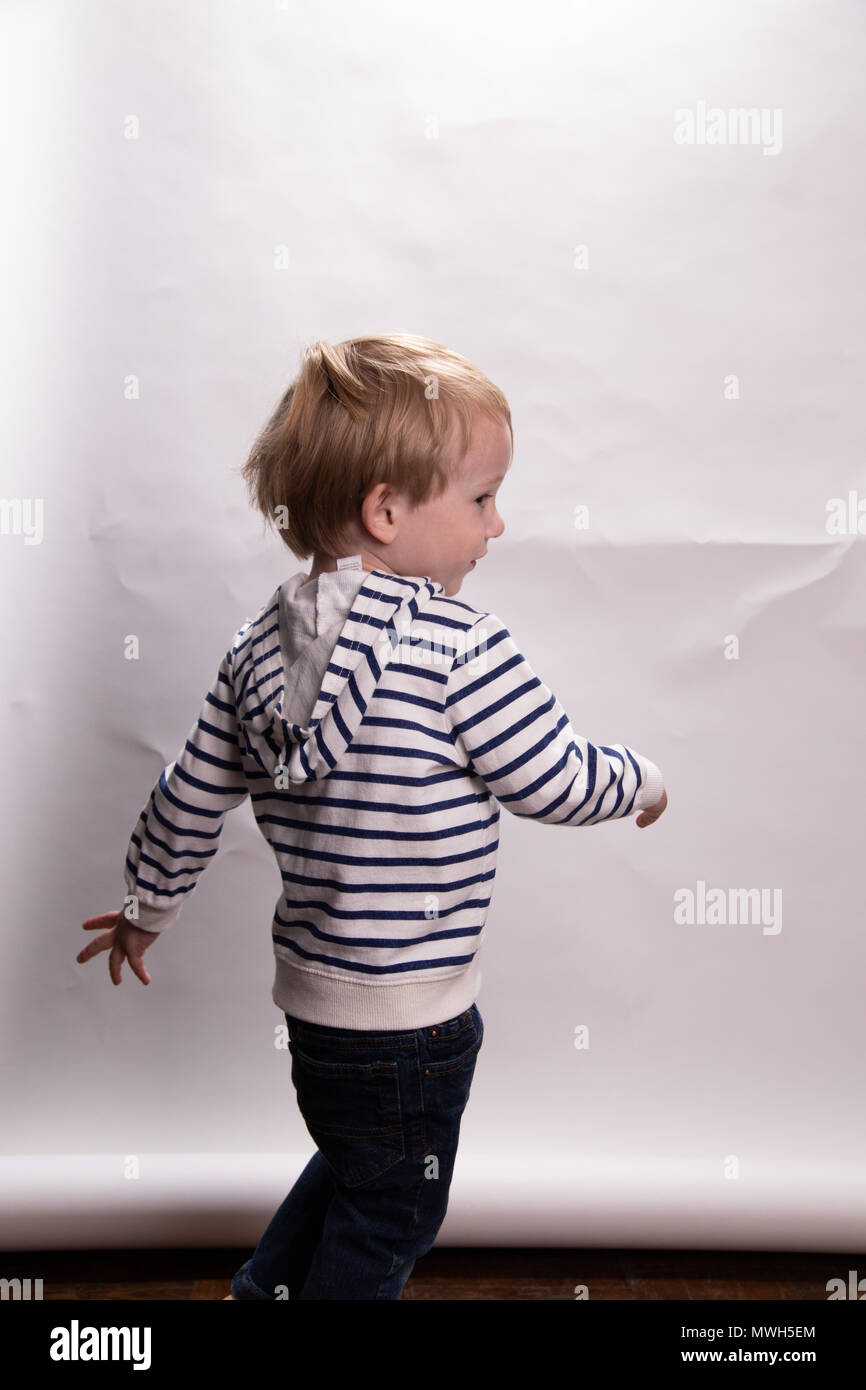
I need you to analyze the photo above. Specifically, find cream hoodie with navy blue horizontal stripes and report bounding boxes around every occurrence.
[125,556,663,1030]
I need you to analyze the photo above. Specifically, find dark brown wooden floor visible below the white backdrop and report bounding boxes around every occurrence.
[1,1247,866,1301]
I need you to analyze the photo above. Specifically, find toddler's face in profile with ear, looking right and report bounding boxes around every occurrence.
[371,405,512,598]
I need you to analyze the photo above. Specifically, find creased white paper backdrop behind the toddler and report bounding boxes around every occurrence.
[0,0,866,1251]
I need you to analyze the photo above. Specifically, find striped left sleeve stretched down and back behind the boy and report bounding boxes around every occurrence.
[124,651,249,931]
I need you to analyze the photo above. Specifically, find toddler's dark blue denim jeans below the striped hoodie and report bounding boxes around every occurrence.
[232,1004,484,1301]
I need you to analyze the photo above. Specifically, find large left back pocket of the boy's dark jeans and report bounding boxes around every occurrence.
[289,1040,405,1187]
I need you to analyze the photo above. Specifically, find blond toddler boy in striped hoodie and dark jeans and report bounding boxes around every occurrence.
[78,334,667,1300]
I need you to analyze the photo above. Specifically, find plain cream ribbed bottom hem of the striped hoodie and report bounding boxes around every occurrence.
[272,948,481,1033]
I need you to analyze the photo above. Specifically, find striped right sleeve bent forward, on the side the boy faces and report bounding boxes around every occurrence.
[445,613,664,826]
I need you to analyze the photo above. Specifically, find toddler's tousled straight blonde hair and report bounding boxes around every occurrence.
[240,334,514,559]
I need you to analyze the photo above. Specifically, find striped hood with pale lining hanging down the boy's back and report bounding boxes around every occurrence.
[234,569,445,787]
